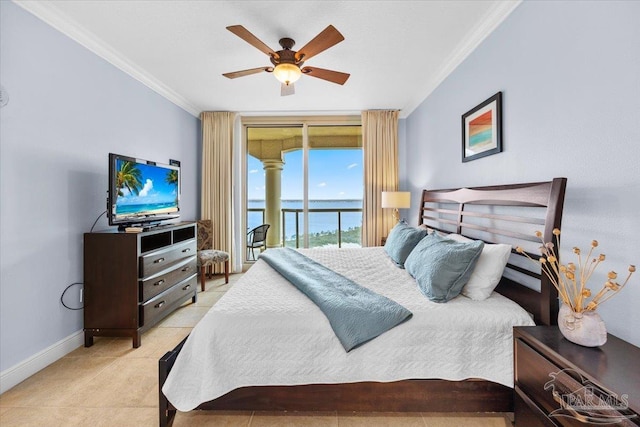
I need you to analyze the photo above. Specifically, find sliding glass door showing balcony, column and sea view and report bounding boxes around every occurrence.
[244,118,363,260]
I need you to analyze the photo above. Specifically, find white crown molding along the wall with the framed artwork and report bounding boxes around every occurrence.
[400,0,523,118]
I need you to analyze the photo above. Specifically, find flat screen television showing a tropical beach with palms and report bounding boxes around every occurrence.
[107,153,180,230]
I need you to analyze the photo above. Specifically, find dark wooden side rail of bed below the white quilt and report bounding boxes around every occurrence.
[198,379,513,412]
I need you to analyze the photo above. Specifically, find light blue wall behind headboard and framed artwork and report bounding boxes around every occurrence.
[403,1,640,346]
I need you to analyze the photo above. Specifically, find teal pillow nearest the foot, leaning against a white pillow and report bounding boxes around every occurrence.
[404,233,484,302]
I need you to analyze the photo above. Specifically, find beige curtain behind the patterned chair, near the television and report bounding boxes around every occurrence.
[200,111,235,272]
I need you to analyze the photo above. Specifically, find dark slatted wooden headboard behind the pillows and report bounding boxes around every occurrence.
[419,178,567,325]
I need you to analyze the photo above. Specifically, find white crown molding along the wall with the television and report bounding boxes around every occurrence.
[14,0,201,117]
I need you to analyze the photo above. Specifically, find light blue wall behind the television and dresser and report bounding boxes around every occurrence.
[0,1,200,371]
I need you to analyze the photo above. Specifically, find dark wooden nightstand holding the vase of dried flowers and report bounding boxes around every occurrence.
[513,326,640,427]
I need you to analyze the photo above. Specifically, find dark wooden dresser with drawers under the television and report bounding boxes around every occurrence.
[84,222,197,347]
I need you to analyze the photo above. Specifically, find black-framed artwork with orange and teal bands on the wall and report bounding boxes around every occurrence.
[462,92,502,162]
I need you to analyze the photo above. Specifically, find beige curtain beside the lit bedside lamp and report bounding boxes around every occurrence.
[362,110,398,246]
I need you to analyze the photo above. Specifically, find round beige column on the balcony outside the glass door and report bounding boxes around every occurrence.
[262,160,284,248]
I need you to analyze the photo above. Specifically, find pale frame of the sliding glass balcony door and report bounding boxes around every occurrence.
[241,114,362,263]
